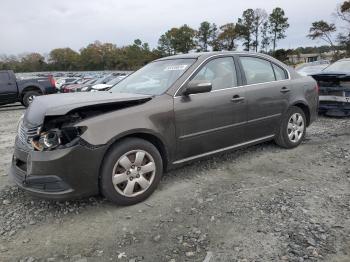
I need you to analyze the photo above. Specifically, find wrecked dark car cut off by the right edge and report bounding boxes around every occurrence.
[312,58,350,116]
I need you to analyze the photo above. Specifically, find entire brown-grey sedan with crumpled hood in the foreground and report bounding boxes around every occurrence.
[10,52,318,205]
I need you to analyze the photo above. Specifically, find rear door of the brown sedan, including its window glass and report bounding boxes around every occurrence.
[239,55,292,140]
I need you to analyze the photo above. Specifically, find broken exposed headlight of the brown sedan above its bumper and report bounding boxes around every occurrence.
[32,126,86,151]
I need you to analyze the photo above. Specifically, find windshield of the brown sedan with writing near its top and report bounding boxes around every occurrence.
[110,59,195,95]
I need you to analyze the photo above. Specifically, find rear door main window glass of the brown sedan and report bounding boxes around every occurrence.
[240,56,275,85]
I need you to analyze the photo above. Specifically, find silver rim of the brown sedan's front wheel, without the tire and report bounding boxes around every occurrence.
[112,150,156,197]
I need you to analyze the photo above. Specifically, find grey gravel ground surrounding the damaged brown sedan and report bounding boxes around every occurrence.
[0,107,350,262]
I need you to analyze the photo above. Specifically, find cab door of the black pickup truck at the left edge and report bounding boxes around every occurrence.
[0,71,17,103]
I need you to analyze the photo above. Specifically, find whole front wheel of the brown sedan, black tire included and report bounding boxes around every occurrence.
[100,138,163,206]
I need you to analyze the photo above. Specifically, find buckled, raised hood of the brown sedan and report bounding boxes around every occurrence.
[24,91,152,127]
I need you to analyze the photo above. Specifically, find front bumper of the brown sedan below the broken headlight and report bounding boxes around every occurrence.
[10,139,105,200]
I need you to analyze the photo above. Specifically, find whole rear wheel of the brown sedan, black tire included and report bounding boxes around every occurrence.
[275,106,306,149]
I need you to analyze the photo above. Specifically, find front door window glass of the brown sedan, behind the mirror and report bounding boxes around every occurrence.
[192,57,237,90]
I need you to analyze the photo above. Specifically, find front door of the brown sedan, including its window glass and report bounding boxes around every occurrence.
[174,56,246,162]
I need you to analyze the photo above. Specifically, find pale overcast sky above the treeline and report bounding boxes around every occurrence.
[0,0,342,54]
